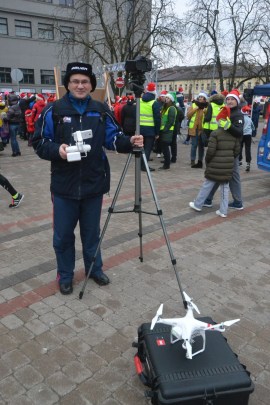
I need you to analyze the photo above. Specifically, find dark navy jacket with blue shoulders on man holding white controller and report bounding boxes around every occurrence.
[32,94,132,199]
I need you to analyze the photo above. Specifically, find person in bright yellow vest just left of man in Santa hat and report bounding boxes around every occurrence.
[201,93,225,146]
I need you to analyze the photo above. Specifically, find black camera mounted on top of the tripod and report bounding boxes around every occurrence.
[125,56,152,97]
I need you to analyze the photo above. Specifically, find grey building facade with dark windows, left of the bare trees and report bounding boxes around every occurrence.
[0,0,87,93]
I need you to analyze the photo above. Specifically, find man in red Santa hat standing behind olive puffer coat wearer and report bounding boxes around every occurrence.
[204,89,244,210]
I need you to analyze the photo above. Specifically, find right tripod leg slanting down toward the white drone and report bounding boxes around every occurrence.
[142,152,187,309]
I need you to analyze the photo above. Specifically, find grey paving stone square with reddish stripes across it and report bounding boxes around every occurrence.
[0,130,270,405]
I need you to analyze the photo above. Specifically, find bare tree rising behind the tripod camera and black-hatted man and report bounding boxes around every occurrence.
[53,0,181,92]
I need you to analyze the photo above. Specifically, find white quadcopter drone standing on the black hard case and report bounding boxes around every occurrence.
[150,291,240,360]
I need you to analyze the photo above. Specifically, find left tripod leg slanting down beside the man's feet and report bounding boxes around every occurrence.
[79,153,132,300]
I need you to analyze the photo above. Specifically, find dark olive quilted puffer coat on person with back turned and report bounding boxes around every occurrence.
[204,128,240,183]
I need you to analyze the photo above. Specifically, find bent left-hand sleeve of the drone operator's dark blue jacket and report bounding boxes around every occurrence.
[32,104,62,161]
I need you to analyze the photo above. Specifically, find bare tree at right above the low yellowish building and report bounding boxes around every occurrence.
[183,0,264,90]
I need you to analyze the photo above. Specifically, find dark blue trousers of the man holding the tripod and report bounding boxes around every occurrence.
[52,195,103,283]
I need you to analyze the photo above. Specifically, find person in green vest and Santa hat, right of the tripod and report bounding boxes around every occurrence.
[159,93,177,170]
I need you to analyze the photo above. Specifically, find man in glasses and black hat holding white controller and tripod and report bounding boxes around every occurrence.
[32,62,143,294]
